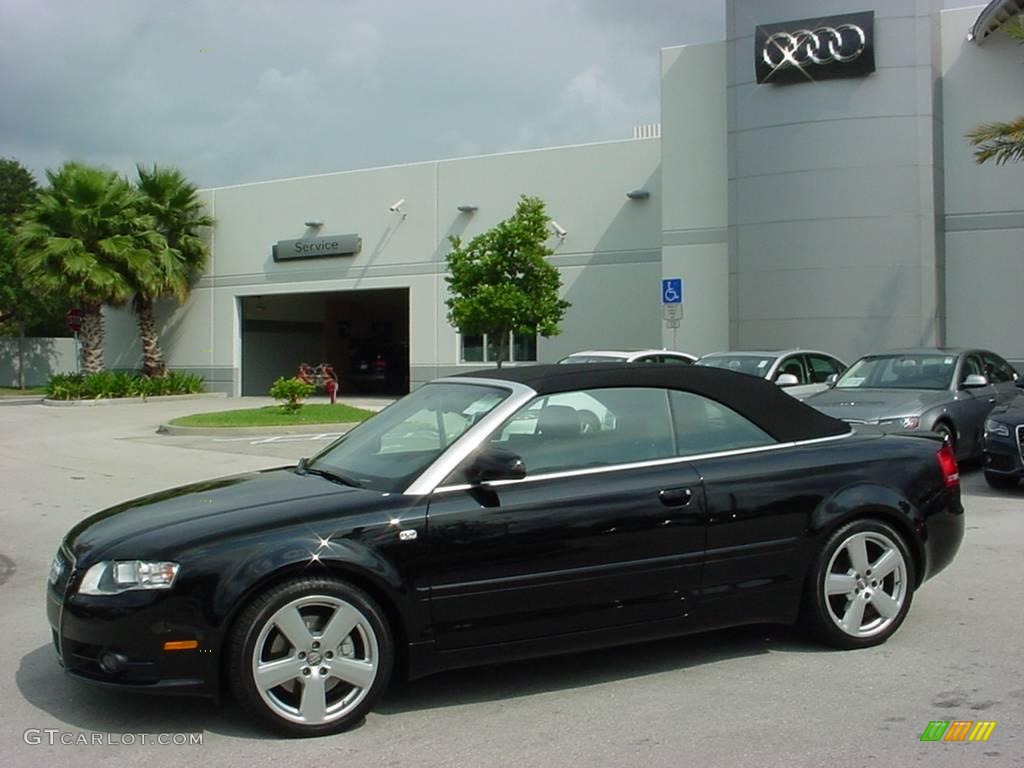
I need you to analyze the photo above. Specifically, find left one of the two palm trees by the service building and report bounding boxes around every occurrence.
[15,162,156,373]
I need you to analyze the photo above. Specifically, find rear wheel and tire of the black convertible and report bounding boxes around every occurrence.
[803,519,915,649]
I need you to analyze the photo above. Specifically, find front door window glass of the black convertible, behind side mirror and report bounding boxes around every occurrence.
[487,387,675,475]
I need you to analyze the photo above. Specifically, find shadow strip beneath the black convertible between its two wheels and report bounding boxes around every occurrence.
[374,625,831,715]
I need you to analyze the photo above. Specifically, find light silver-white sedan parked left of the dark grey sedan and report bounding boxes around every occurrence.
[697,349,846,400]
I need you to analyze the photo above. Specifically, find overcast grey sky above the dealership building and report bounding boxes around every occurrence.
[0,0,976,186]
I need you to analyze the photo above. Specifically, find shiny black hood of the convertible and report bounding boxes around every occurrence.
[65,467,368,561]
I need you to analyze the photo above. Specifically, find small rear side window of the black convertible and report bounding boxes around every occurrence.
[669,391,775,456]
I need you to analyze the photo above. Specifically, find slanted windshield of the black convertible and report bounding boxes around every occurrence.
[308,383,509,493]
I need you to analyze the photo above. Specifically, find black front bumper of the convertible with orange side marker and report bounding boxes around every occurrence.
[46,550,219,696]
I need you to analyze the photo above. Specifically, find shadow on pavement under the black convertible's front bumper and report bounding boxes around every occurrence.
[14,645,275,738]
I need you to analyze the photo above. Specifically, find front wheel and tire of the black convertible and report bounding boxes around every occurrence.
[227,577,394,736]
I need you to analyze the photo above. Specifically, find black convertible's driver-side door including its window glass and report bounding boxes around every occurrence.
[427,387,705,651]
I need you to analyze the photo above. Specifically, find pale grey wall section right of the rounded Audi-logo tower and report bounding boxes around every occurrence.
[942,6,1024,368]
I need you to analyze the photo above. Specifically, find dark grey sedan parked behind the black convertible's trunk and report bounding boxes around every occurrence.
[808,348,1018,460]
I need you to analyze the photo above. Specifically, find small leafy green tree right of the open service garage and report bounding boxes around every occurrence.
[444,195,570,368]
